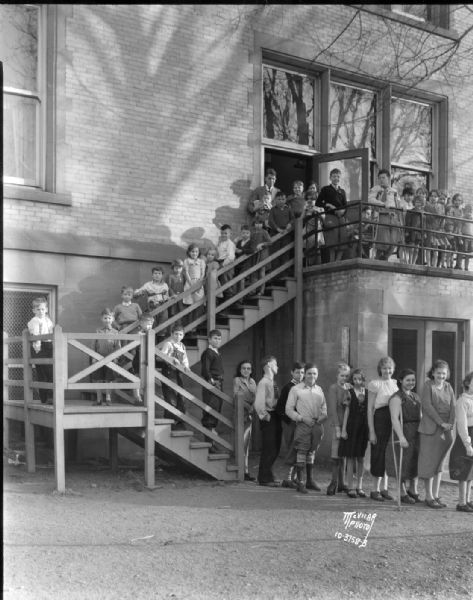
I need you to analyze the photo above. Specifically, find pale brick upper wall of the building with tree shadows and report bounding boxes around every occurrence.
[4,5,473,246]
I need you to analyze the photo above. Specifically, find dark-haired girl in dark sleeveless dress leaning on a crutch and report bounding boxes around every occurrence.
[386,369,421,504]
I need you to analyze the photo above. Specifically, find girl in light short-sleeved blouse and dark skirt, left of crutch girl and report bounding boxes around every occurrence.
[368,356,398,502]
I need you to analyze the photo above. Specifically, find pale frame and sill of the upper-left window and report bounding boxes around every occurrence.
[3,4,71,205]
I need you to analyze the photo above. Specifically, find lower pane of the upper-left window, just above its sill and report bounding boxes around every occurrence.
[3,94,39,185]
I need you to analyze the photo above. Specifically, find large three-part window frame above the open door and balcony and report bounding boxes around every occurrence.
[253,33,448,189]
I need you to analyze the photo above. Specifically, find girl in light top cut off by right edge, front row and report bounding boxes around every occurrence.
[449,371,473,513]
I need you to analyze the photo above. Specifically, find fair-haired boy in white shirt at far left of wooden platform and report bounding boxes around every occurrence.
[27,297,54,404]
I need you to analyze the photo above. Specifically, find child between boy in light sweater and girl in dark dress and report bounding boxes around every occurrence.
[327,362,350,496]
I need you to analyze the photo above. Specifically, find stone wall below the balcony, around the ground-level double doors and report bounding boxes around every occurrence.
[304,269,473,385]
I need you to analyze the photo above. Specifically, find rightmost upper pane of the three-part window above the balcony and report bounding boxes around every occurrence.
[391,98,432,169]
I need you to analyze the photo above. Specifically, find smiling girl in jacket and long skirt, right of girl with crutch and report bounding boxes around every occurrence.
[419,360,455,508]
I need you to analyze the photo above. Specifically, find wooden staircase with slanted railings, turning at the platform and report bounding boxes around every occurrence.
[115,226,303,481]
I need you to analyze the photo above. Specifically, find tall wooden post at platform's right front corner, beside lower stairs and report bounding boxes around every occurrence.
[145,329,156,488]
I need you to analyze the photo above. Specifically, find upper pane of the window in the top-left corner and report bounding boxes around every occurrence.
[0,4,39,92]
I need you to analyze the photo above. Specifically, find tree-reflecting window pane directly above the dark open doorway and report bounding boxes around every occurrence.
[263,66,314,146]
